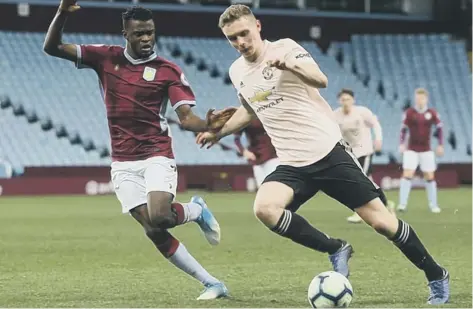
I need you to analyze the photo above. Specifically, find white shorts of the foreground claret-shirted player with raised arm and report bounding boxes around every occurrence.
[110,157,177,213]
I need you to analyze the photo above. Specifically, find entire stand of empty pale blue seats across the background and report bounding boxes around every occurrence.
[0,32,471,168]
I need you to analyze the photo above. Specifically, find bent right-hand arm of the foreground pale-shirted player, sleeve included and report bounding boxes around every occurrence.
[270,39,328,88]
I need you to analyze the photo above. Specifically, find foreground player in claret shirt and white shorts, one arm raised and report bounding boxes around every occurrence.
[44,0,227,299]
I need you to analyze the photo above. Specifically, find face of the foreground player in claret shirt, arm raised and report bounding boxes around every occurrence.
[123,19,156,58]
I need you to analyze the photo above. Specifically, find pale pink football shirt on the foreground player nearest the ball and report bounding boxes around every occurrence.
[229,39,342,167]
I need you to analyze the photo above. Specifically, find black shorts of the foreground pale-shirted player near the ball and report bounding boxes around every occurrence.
[263,143,381,211]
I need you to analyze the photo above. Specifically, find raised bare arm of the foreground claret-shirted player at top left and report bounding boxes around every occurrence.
[43,0,80,62]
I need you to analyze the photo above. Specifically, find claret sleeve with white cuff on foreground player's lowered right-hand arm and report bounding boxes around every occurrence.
[163,65,195,110]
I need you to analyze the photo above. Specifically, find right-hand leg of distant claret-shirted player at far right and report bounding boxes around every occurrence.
[420,151,441,213]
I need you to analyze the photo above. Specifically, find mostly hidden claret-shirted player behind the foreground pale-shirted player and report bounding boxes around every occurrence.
[234,119,279,188]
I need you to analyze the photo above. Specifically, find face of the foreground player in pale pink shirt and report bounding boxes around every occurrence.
[222,17,263,61]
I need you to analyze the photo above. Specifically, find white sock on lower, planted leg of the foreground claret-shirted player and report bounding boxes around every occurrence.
[169,243,220,284]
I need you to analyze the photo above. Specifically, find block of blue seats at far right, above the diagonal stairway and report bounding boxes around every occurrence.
[332,34,472,162]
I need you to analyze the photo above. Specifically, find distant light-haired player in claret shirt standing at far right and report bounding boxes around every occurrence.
[397,88,444,213]
